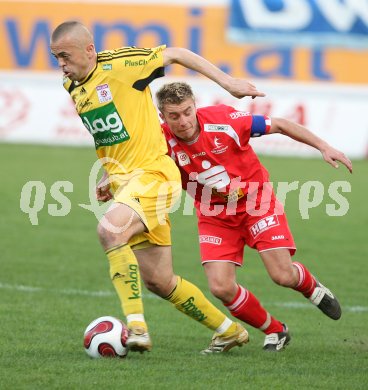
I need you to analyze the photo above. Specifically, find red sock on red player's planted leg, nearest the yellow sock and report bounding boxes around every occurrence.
[225,285,283,334]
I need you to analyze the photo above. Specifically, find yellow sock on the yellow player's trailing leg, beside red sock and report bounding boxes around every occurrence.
[165,276,236,336]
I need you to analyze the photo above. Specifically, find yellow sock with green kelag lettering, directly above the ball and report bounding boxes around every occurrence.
[106,244,147,330]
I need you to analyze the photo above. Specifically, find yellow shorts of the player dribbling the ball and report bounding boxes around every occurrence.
[111,155,181,246]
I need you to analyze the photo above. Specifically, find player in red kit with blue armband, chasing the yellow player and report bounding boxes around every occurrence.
[156,82,352,353]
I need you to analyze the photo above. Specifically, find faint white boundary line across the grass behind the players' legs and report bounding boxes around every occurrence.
[0,282,368,313]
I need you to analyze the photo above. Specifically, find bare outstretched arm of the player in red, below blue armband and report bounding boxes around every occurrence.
[269,118,353,173]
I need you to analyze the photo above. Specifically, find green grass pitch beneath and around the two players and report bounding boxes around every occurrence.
[0,144,368,390]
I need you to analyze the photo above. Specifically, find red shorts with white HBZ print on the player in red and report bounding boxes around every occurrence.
[197,200,296,265]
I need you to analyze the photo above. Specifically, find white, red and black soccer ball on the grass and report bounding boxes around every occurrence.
[84,316,128,358]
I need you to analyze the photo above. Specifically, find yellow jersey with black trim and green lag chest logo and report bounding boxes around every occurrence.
[64,45,167,175]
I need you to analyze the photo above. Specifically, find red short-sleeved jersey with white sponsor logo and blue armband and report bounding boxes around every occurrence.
[162,105,272,213]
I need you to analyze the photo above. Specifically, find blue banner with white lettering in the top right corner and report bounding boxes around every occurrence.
[228,0,368,49]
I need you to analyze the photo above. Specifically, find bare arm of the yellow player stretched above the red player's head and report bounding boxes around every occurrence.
[163,47,265,99]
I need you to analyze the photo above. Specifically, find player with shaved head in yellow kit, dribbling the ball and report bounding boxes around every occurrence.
[50,21,264,352]
